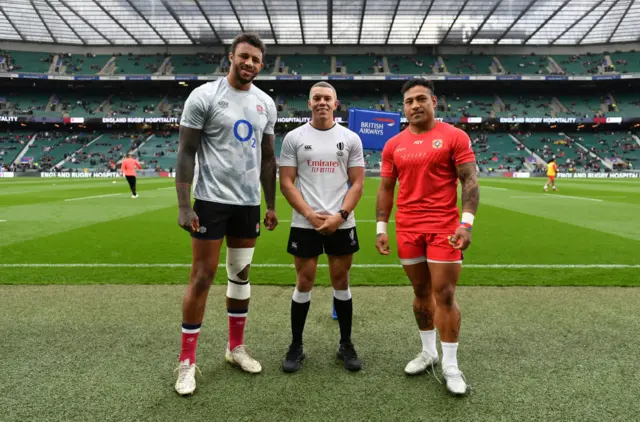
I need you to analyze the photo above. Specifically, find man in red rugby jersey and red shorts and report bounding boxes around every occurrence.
[376,79,480,395]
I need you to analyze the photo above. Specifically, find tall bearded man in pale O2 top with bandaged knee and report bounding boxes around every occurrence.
[175,34,278,395]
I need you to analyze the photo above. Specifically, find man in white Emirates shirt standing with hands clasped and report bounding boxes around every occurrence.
[280,82,364,372]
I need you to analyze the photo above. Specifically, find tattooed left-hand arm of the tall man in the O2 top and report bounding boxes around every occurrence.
[176,126,202,232]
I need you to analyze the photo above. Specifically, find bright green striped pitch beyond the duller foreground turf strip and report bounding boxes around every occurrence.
[0,178,640,286]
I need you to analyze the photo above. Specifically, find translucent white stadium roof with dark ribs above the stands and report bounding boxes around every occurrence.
[0,0,640,46]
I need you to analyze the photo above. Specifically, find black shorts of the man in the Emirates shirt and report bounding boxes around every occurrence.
[287,227,360,258]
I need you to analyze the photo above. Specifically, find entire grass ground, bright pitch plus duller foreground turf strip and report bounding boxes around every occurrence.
[0,178,640,421]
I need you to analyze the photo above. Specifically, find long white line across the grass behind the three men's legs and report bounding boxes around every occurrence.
[0,263,640,269]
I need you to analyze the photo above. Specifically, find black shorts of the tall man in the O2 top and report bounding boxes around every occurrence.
[191,199,260,240]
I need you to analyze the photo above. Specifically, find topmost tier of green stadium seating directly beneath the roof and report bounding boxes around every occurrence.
[0,51,640,75]
